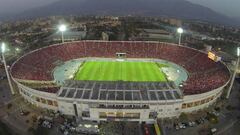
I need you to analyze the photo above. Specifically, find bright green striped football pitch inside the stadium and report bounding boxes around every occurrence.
[74,61,166,82]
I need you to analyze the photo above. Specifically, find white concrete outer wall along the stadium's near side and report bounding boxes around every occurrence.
[14,78,227,122]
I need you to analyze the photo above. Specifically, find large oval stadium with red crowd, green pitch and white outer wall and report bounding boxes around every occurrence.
[10,41,230,122]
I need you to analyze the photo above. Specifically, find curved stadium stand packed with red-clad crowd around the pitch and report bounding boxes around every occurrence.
[11,41,230,95]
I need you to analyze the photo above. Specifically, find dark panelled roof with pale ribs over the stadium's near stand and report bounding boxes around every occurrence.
[58,80,182,101]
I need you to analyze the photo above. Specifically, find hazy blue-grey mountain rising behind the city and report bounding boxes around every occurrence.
[1,0,239,26]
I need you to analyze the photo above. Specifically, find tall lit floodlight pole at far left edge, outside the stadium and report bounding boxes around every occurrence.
[1,43,15,95]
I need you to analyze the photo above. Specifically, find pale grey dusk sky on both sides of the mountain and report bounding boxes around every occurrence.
[0,0,240,18]
